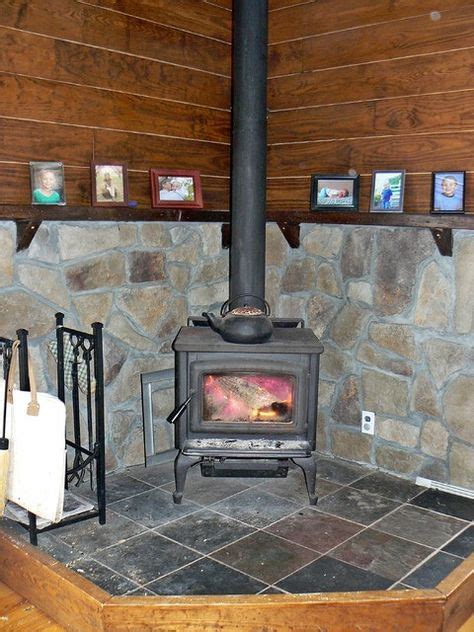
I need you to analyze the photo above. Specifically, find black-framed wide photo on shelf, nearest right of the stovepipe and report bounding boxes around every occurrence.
[311,173,359,211]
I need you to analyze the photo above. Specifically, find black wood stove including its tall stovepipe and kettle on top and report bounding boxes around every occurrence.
[168,0,323,504]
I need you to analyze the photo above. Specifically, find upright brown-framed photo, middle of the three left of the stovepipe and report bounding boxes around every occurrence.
[91,161,128,206]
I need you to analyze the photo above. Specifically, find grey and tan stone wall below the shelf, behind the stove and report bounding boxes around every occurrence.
[0,222,474,489]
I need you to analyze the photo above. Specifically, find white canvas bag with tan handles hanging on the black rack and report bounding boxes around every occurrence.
[0,345,66,522]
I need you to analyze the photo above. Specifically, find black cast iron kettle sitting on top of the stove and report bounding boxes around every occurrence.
[202,294,273,344]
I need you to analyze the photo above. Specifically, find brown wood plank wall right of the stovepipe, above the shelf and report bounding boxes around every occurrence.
[268,0,474,213]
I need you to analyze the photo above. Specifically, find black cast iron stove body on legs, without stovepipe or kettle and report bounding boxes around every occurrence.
[170,319,323,504]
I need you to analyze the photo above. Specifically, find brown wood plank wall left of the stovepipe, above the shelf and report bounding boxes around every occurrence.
[0,0,231,210]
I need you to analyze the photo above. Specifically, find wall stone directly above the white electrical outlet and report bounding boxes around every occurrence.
[362,369,408,417]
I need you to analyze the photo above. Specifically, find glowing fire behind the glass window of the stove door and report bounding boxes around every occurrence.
[203,373,295,423]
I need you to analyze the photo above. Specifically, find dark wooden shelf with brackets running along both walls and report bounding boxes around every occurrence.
[0,205,474,256]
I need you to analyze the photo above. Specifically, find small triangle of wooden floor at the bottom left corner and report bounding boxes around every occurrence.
[0,582,66,632]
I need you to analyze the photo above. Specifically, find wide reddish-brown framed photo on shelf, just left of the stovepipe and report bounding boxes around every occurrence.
[150,169,203,208]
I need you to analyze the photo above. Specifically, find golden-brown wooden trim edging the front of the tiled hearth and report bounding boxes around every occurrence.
[0,529,474,632]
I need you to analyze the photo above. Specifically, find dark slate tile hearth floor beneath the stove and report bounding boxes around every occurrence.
[0,457,474,595]
